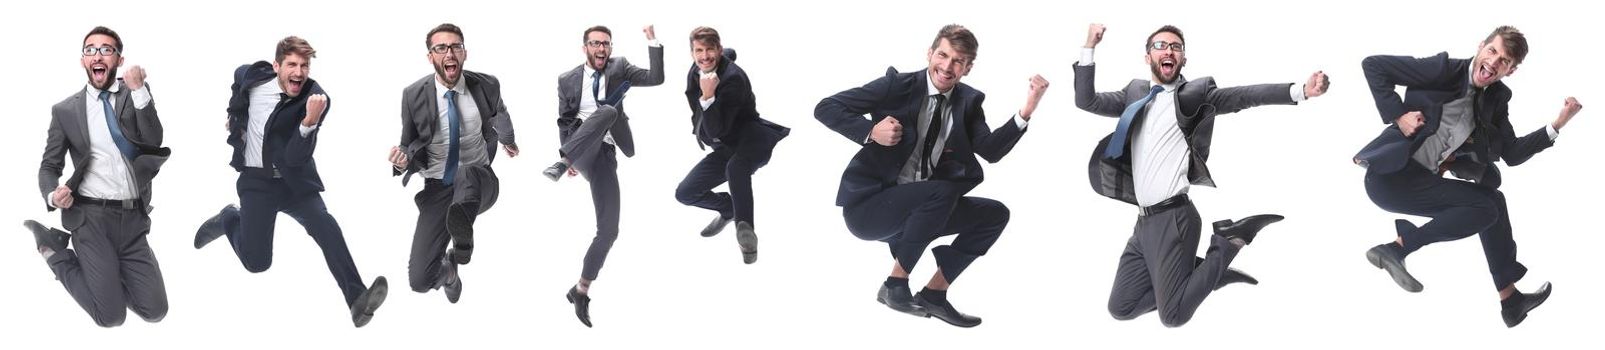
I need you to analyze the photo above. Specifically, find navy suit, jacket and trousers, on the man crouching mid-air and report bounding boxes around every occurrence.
[814,69,1026,281]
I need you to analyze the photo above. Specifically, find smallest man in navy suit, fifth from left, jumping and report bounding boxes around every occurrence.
[674,27,791,263]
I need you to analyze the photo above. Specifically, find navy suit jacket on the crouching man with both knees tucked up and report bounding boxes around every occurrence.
[814,67,1026,207]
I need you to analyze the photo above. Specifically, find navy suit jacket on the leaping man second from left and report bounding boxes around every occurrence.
[228,61,334,196]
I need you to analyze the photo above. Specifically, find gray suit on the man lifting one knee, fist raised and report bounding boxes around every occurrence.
[557,47,663,279]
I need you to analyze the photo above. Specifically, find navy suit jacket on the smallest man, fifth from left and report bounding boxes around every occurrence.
[685,48,791,153]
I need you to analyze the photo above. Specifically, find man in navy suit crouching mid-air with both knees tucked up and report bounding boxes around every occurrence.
[814,24,1048,328]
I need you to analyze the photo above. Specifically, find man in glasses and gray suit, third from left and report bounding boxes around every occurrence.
[390,22,518,303]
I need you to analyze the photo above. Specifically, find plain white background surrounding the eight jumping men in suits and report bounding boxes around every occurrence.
[0,0,1605,348]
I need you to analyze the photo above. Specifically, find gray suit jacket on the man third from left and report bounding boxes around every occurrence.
[390,71,515,186]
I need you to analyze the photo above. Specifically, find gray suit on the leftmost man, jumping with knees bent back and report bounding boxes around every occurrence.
[39,82,172,328]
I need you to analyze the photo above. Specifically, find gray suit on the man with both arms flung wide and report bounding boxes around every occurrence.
[1075,64,1295,328]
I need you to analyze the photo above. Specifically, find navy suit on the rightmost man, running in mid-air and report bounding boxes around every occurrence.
[1355,53,1554,289]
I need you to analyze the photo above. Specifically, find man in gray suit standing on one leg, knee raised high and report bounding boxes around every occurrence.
[542,26,663,328]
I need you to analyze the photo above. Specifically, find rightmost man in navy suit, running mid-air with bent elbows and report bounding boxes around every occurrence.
[1355,26,1583,328]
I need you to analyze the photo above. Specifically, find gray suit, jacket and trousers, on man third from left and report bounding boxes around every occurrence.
[392,71,515,292]
